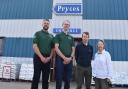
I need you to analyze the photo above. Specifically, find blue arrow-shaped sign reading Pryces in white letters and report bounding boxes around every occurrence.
[54,3,82,14]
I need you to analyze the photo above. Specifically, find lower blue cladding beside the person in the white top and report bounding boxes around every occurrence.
[106,40,128,61]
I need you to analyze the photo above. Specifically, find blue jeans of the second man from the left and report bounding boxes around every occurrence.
[56,56,73,89]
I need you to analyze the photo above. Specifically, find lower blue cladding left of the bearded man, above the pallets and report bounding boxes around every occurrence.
[3,38,33,57]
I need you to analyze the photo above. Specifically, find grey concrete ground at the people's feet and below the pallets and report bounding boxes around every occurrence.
[0,80,128,89]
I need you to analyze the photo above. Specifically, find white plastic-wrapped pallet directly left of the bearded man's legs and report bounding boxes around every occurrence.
[19,64,34,81]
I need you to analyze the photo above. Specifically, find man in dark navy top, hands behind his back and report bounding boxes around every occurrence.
[75,32,93,89]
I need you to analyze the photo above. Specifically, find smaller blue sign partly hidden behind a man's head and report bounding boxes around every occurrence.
[53,28,81,34]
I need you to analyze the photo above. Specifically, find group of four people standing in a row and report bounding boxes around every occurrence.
[31,19,112,89]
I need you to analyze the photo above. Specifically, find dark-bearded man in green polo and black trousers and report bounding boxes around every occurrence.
[31,19,53,89]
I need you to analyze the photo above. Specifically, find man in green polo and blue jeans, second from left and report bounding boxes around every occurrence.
[55,20,75,89]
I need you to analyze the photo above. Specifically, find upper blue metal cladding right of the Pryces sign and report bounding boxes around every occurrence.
[83,0,128,20]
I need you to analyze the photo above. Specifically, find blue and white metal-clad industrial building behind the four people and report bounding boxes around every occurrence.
[0,0,128,84]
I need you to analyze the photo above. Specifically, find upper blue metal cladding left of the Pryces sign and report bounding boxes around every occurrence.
[0,0,53,19]
